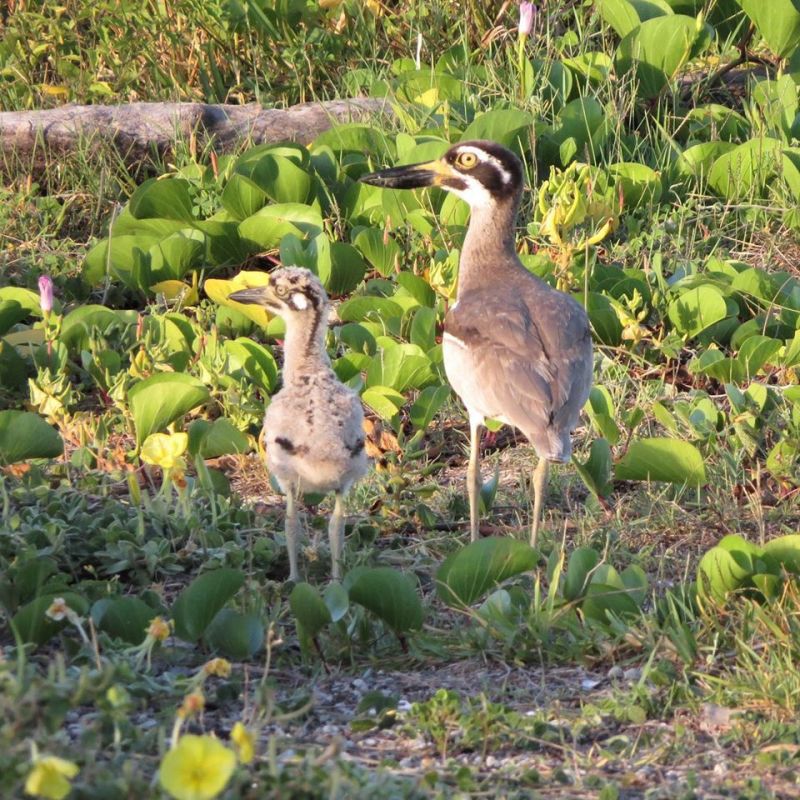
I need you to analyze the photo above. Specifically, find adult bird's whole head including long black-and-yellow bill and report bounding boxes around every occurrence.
[360,141,523,209]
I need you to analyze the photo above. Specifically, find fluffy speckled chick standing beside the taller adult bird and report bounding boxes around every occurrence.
[232,267,368,581]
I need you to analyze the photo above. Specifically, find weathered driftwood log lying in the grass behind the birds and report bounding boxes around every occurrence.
[0,98,391,166]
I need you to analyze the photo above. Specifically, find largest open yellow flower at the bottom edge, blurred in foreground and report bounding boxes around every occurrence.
[158,734,236,800]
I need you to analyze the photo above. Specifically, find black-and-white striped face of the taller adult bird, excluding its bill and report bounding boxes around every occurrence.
[441,141,523,207]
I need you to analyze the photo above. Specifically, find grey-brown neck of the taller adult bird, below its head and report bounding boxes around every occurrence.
[458,199,519,296]
